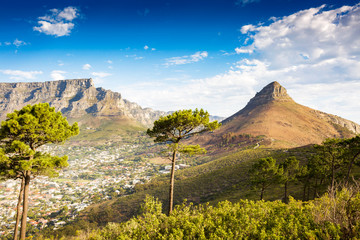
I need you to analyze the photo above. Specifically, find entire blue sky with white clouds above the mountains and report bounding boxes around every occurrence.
[0,0,360,123]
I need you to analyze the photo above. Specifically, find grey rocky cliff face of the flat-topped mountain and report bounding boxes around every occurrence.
[0,79,164,125]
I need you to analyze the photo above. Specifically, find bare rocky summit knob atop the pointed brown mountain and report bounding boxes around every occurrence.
[248,81,293,106]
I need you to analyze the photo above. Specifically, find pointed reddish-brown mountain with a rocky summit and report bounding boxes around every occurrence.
[200,82,360,147]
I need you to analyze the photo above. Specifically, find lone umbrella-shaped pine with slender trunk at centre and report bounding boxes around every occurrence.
[147,109,221,215]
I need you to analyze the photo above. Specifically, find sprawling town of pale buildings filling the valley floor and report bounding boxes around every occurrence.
[0,140,188,236]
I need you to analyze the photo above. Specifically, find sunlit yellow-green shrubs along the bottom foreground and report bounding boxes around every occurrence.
[40,188,360,240]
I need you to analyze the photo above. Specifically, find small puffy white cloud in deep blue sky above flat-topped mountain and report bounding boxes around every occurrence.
[33,6,79,37]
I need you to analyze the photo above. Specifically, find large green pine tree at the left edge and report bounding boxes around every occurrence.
[0,103,79,239]
